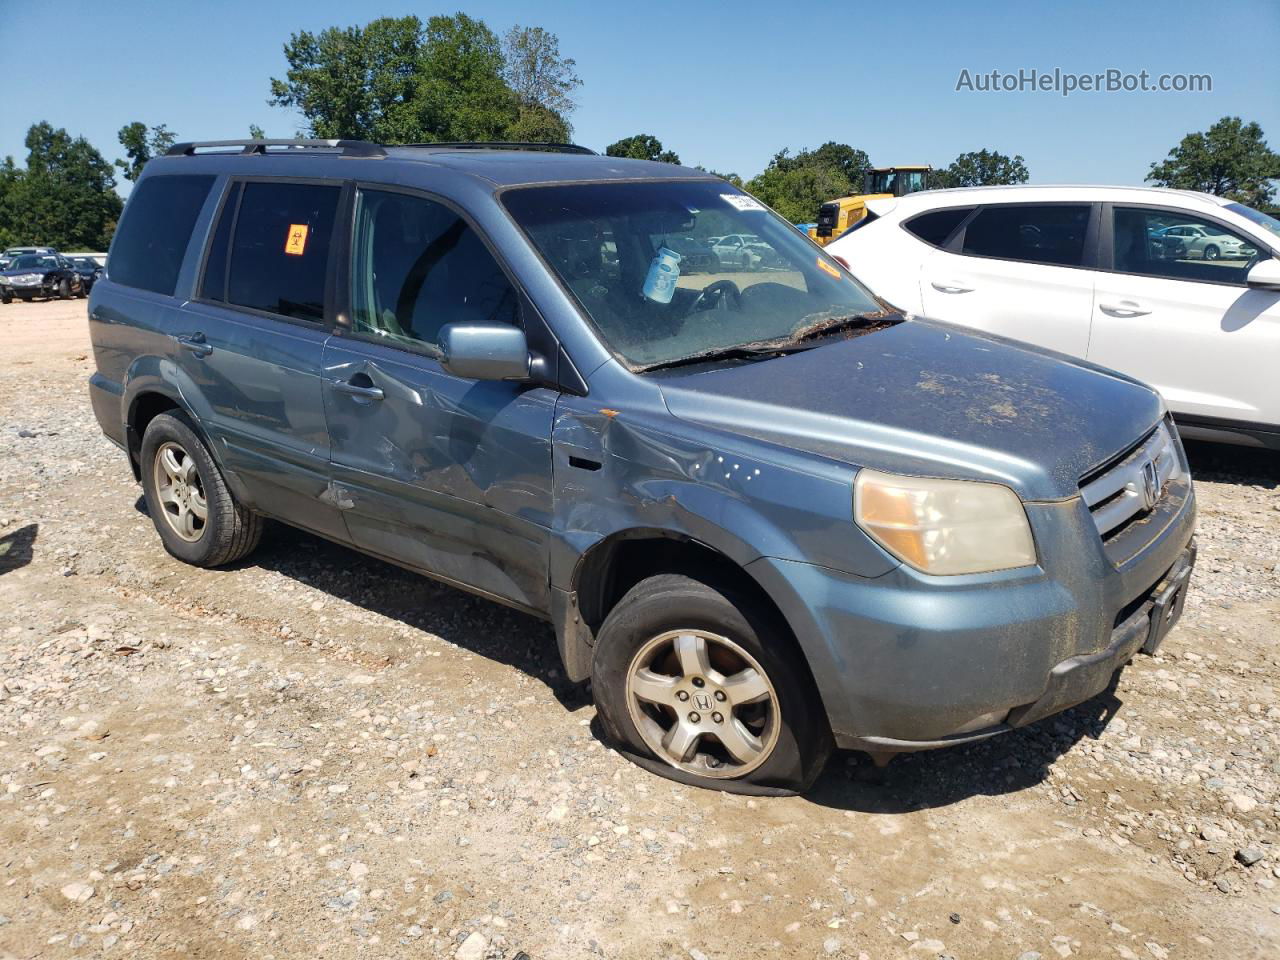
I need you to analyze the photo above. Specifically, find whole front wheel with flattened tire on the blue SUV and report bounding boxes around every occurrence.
[591,573,832,794]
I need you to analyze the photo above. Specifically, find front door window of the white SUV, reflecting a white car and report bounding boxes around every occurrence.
[1111,206,1258,284]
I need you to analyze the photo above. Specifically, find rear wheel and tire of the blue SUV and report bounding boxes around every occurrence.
[142,411,262,567]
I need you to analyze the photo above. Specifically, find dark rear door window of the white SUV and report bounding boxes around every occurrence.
[961,204,1091,266]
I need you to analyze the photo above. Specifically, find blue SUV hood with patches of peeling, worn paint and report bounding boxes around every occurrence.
[660,320,1164,500]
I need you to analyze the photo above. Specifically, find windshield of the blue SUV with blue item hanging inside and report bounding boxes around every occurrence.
[503,180,884,369]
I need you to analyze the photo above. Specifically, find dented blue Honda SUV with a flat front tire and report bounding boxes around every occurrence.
[90,141,1196,794]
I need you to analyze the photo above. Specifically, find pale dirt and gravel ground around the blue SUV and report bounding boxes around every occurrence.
[0,301,1280,960]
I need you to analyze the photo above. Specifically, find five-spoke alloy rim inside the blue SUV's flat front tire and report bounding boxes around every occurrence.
[627,630,778,778]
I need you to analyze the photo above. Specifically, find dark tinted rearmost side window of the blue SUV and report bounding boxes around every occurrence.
[108,174,214,297]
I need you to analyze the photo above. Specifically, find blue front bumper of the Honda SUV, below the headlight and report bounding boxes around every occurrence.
[748,473,1196,751]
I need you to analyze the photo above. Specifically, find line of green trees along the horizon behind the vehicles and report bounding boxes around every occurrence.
[0,13,1280,250]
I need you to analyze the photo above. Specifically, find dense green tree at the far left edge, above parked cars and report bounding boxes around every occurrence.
[0,123,123,250]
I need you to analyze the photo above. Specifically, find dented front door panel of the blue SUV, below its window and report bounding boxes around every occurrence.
[324,338,557,612]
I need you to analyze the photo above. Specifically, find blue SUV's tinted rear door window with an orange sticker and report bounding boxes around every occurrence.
[227,182,340,320]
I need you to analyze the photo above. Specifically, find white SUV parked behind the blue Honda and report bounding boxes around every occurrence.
[827,186,1280,449]
